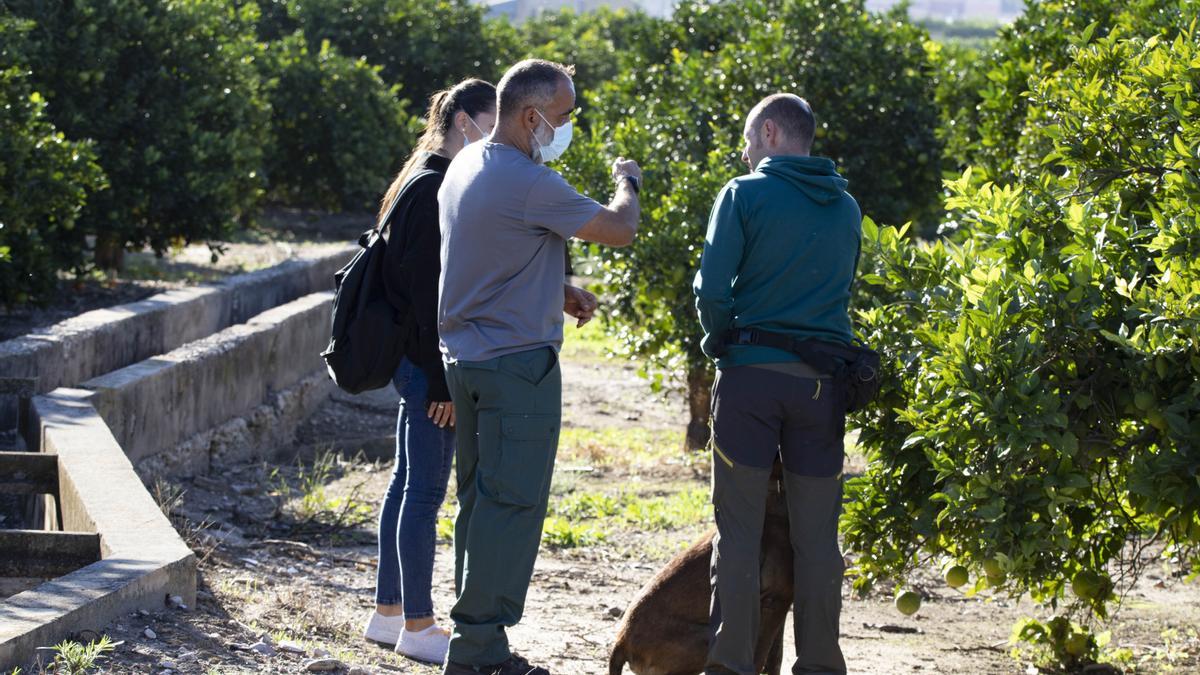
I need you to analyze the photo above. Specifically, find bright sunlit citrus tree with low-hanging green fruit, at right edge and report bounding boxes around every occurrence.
[842,2,1200,664]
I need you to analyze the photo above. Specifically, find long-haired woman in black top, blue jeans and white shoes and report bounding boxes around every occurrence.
[364,79,496,663]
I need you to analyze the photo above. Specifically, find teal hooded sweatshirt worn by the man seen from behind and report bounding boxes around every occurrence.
[692,156,863,368]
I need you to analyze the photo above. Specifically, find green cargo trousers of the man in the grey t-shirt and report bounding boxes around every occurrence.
[446,347,563,665]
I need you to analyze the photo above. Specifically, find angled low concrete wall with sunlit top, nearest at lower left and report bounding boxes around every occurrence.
[0,389,196,671]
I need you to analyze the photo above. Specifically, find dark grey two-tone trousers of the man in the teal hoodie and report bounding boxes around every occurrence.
[704,368,846,675]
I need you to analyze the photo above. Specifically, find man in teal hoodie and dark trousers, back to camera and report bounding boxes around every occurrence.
[694,94,862,675]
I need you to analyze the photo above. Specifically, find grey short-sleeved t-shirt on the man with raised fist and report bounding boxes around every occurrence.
[438,143,602,363]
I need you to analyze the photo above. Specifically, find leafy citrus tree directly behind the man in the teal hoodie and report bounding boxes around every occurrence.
[563,0,940,448]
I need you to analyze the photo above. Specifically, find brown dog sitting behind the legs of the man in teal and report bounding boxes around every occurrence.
[608,461,792,675]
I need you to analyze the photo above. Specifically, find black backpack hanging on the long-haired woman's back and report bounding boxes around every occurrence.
[320,171,434,394]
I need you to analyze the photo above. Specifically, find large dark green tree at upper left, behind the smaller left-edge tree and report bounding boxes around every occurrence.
[5,0,266,263]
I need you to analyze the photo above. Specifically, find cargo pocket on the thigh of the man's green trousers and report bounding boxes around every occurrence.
[479,412,559,507]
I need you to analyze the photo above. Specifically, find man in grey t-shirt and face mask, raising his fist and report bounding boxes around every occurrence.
[438,59,641,675]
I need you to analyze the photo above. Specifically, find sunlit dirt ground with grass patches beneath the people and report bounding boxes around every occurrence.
[11,317,1200,675]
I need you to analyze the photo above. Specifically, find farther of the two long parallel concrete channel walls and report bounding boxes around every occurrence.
[0,247,355,393]
